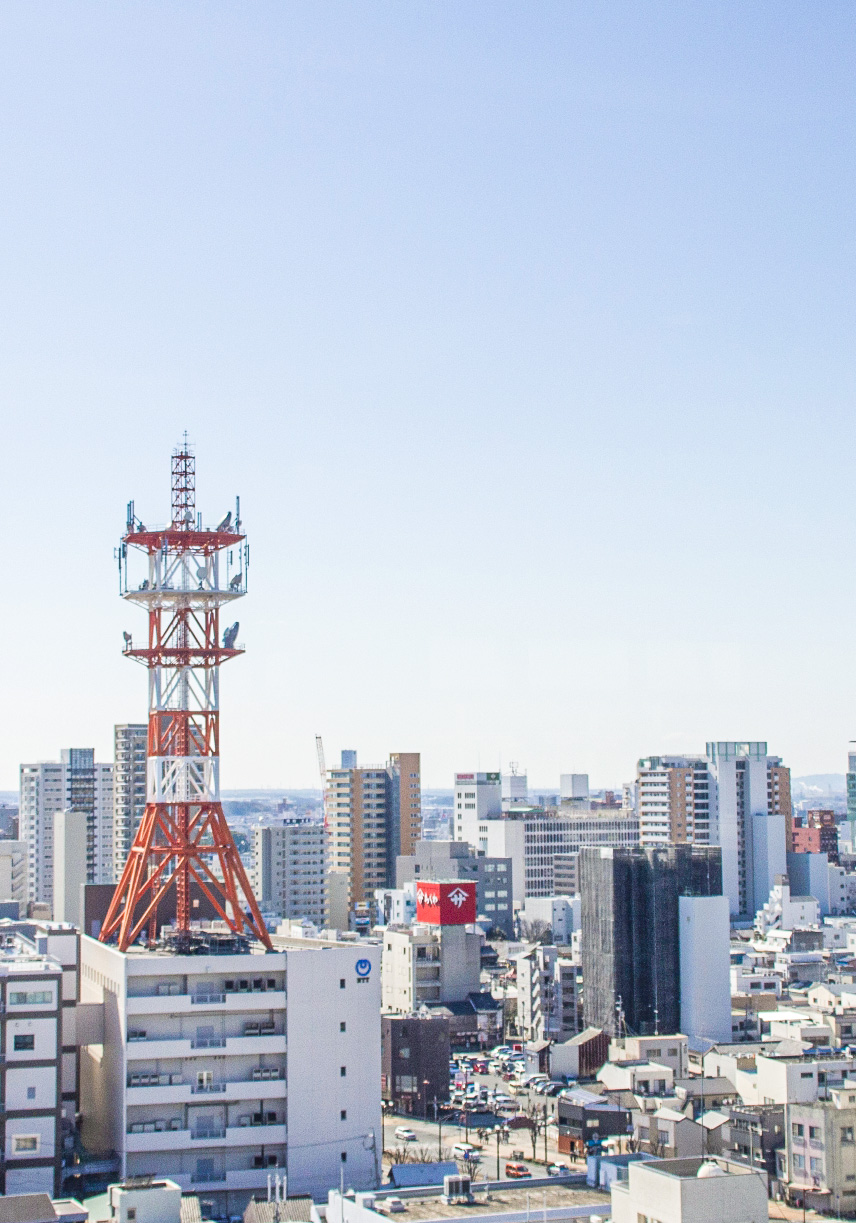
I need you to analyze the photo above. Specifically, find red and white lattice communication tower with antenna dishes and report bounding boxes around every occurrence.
[100,440,271,950]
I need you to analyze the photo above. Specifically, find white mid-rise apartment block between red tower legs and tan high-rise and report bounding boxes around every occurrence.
[252,816,327,928]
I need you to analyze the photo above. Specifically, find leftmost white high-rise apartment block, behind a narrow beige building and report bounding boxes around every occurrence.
[20,747,113,905]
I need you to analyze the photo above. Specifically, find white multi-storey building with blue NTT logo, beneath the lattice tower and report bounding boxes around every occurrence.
[81,937,382,1218]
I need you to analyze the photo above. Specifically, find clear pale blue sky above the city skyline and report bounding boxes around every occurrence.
[0,0,856,788]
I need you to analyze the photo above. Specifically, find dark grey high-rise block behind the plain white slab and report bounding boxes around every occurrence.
[578,845,723,1036]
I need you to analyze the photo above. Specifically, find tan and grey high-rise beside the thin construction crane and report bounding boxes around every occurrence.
[325,752,422,928]
